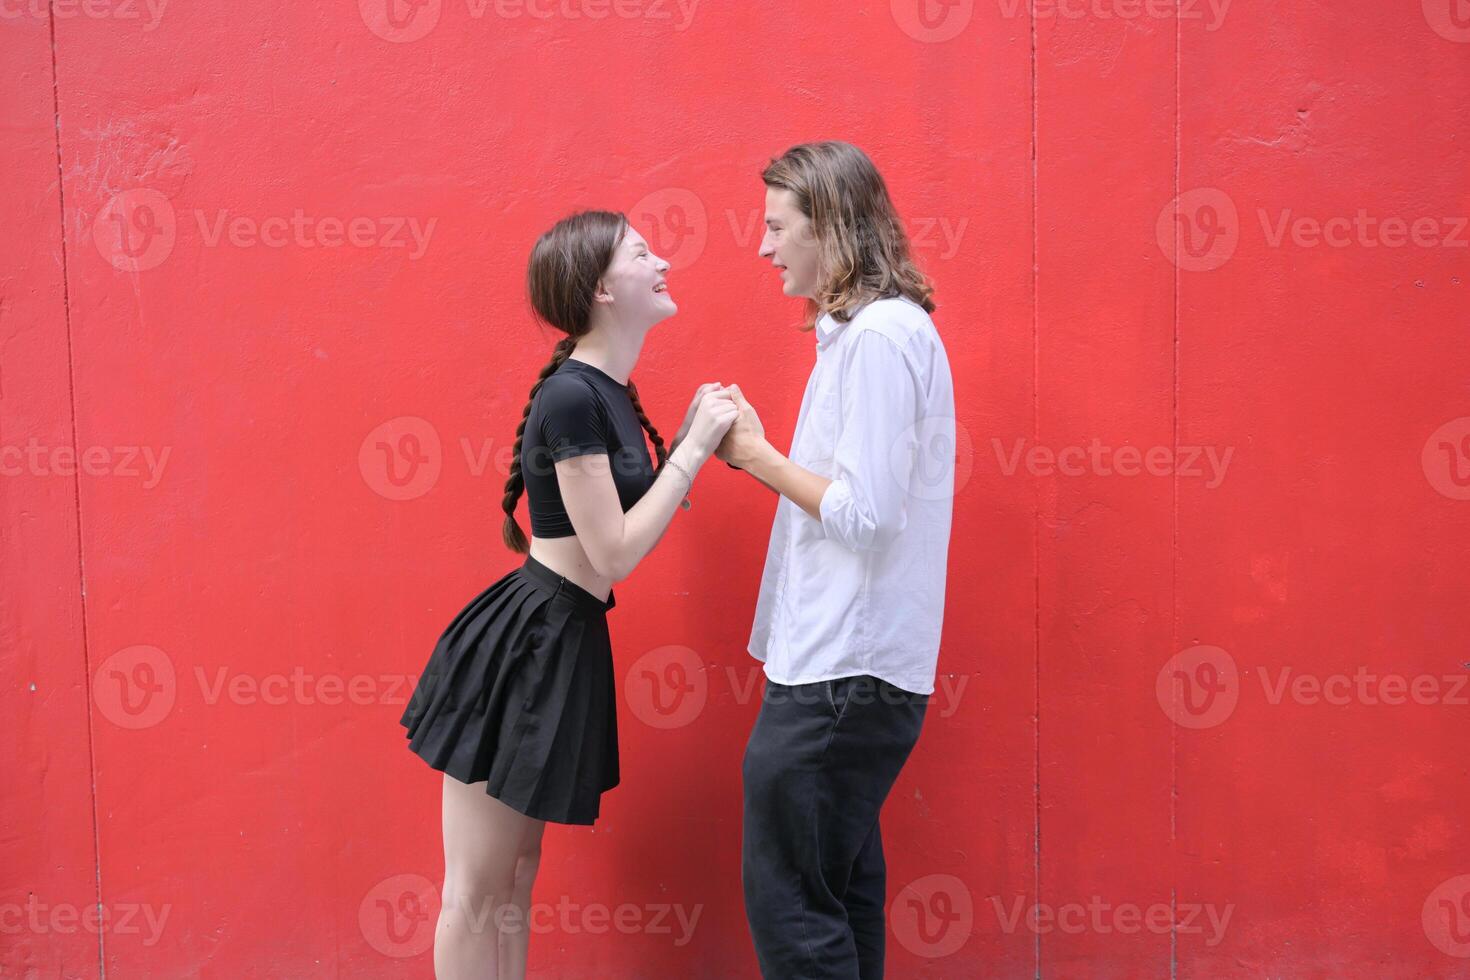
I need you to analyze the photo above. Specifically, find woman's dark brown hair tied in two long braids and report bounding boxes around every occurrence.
[500,212,669,554]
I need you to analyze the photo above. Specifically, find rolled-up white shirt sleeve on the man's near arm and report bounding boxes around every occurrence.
[819,331,919,551]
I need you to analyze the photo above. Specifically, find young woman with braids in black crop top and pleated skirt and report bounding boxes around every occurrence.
[401,212,738,980]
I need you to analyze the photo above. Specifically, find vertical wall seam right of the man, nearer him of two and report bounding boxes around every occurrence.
[1028,6,1041,980]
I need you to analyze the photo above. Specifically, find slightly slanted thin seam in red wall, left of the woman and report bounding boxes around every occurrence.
[46,0,107,980]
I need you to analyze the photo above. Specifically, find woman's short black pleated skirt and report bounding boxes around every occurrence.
[401,555,619,824]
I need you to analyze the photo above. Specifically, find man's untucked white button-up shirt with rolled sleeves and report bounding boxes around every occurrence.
[748,298,956,693]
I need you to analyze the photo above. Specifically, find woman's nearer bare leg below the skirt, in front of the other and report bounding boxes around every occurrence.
[434,773,539,980]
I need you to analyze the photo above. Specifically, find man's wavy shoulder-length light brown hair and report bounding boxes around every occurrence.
[760,140,935,329]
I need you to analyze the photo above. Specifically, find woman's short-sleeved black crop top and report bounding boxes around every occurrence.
[520,359,654,538]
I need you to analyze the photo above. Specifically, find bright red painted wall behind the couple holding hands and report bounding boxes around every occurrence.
[0,0,1470,979]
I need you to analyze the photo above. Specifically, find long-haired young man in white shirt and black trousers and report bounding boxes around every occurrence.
[717,143,954,980]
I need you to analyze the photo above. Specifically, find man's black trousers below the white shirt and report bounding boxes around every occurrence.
[741,674,929,980]
